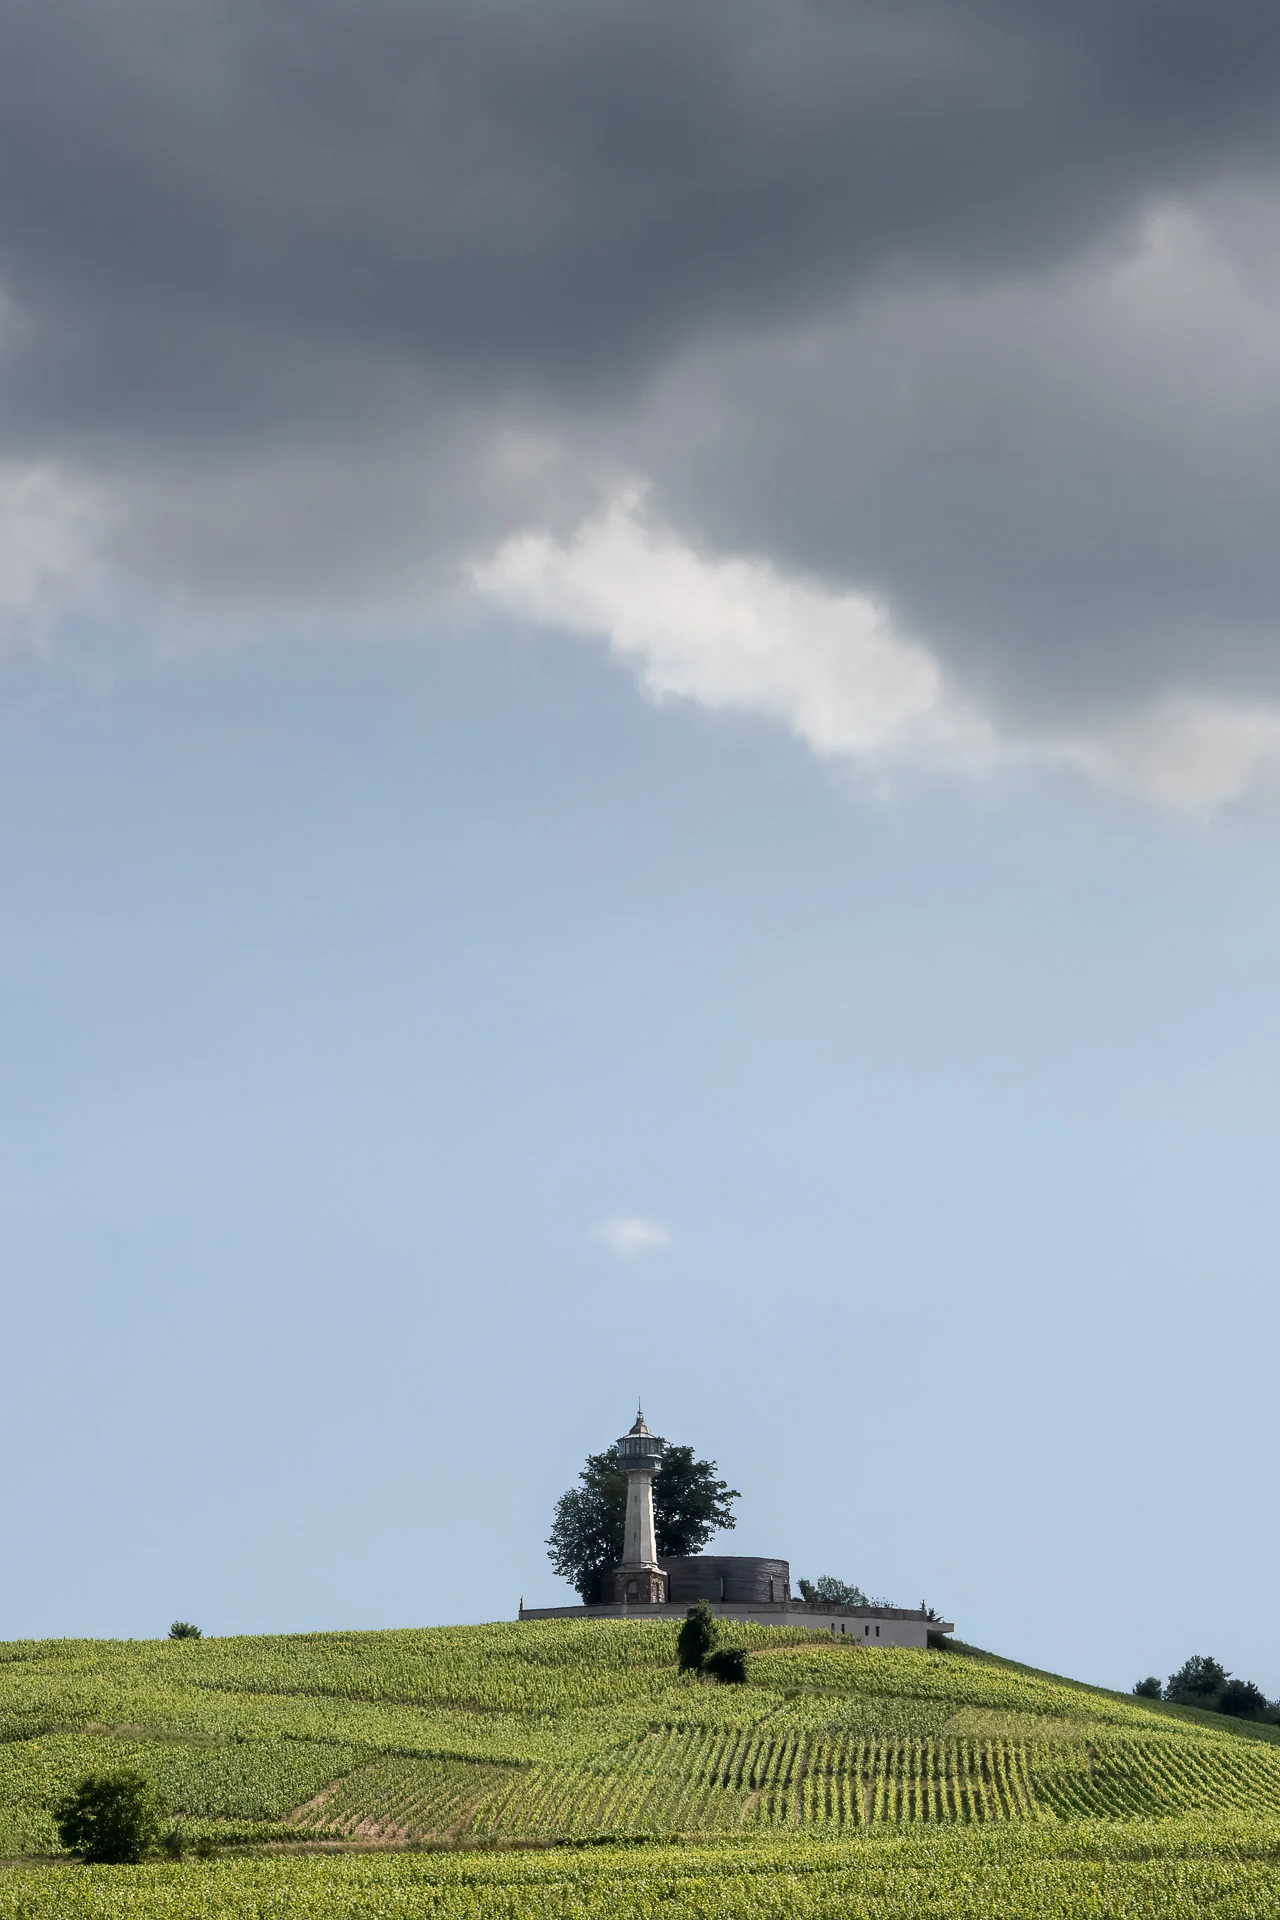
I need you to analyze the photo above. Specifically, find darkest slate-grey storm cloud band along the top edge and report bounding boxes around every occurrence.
[0,0,1280,430]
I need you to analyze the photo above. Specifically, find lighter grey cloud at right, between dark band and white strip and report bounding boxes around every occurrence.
[645,204,1280,718]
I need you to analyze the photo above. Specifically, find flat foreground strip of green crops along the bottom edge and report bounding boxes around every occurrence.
[0,1816,1280,1920]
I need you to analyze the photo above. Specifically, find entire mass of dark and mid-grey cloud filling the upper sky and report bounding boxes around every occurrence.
[0,0,1280,718]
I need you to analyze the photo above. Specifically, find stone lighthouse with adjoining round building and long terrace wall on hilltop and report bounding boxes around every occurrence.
[518,1411,956,1647]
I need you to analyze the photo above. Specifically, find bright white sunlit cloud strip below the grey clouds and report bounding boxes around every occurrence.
[470,488,1280,814]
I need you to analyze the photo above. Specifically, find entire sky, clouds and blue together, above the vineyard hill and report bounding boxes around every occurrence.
[0,0,1280,1695]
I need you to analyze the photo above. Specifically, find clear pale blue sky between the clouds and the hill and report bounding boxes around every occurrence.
[0,628,1280,1692]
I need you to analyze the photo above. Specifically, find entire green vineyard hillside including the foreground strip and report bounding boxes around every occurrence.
[0,1620,1280,1920]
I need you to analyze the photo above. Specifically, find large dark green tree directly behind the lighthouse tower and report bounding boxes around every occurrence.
[547,1446,743,1603]
